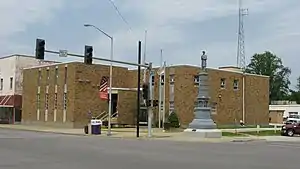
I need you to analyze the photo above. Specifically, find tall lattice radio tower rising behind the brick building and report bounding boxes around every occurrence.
[237,0,248,70]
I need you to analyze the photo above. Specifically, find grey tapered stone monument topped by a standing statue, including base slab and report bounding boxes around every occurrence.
[185,51,222,138]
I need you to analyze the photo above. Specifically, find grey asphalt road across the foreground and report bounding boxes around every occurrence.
[0,129,300,169]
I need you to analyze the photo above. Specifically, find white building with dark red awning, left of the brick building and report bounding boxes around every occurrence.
[0,55,57,123]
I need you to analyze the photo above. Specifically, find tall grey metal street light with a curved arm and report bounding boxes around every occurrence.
[84,24,114,136]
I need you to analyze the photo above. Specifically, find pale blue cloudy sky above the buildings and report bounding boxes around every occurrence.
[0,0,300,87]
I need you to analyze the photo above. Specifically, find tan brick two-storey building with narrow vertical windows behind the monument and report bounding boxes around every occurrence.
[22,62,269,128]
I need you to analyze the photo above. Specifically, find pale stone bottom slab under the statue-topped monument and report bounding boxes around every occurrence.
[184,128,222,138]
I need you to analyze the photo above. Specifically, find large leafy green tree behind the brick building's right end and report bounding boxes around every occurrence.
[246,51,292,101]
